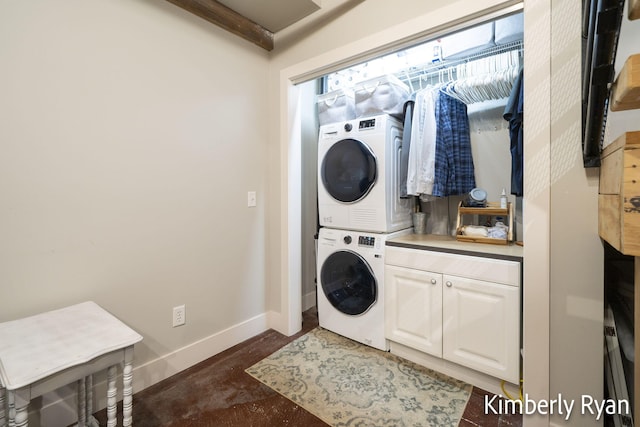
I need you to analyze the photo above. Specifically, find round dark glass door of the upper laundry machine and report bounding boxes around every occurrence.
[321,139,377,203]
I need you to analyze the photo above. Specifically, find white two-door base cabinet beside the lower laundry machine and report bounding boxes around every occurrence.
[385,247,520,384]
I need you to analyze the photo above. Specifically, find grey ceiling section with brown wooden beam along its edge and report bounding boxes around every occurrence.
[167,0,330,51]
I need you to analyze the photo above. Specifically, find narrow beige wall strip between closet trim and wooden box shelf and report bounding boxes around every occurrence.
[548,0,604,426]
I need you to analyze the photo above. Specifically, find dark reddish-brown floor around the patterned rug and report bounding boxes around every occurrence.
[96,310,522,427]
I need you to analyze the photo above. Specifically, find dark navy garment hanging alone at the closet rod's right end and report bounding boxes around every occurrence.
[503,68,524,196]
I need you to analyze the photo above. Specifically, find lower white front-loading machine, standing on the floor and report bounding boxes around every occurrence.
[317,227,411,351]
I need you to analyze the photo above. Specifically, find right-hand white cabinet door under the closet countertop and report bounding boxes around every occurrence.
[442,275,520,384]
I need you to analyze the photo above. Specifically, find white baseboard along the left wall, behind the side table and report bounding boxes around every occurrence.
[36,312,278,427]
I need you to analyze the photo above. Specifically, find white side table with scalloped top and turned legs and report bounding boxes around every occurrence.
[0,301,142,427]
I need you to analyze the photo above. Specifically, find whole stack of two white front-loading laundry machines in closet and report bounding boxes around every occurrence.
[317,94,413,351]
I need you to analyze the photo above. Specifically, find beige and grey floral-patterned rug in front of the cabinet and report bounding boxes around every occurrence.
[246,328,472,427]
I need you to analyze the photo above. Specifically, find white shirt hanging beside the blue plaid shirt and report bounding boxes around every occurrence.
[407,88,439,196]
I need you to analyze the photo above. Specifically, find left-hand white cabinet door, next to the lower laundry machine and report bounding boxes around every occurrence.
[384,265,442,357]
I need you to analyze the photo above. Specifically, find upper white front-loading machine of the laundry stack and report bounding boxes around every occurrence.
[318,115,413,233]
